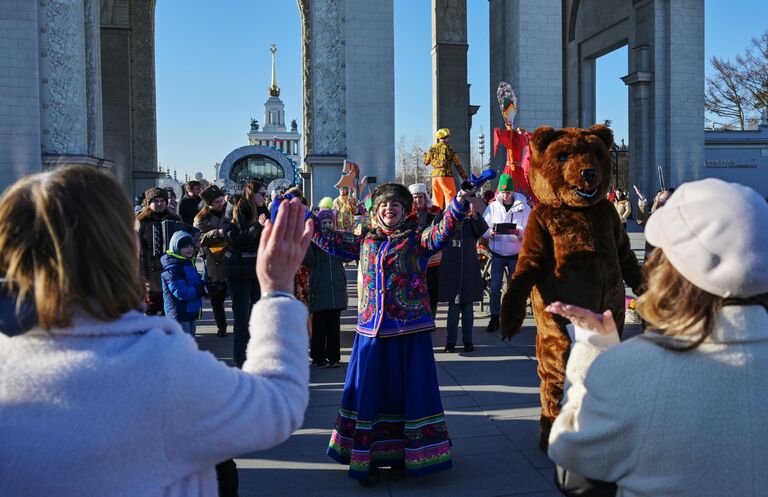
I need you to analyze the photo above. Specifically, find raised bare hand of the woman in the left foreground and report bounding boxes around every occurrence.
[256,198,314,293]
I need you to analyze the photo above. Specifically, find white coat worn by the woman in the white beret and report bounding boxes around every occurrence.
[549,306,768,497]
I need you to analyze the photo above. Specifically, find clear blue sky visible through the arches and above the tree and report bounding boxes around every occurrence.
[155,0,768,179]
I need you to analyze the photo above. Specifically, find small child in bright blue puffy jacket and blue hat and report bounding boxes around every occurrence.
[161,231,204,336]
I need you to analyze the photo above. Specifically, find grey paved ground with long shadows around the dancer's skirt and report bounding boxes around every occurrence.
[198,226,643,497]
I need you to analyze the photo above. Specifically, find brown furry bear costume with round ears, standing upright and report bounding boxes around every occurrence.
[500,125,642,451]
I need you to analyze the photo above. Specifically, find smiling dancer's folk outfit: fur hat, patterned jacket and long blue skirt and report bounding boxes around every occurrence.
[314,183,469,481]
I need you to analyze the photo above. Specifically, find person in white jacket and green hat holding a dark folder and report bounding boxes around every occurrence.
[483,174,531,333]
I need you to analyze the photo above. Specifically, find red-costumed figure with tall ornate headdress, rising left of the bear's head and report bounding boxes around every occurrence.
[493,81,537,204]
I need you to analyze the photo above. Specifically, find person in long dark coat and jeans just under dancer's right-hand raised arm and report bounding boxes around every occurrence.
[436,197,488,352]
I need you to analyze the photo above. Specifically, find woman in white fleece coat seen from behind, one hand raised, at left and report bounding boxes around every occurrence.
[0,167,312,497]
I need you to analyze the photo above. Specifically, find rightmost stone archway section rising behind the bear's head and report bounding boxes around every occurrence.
[563,0,704,191]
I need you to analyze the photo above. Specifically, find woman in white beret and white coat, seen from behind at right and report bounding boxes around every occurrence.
[547,178,768,497]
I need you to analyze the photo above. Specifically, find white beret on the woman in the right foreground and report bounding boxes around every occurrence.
[645,178,768,298]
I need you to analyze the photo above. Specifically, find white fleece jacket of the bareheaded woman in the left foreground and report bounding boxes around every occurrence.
[0,298,309,497]
